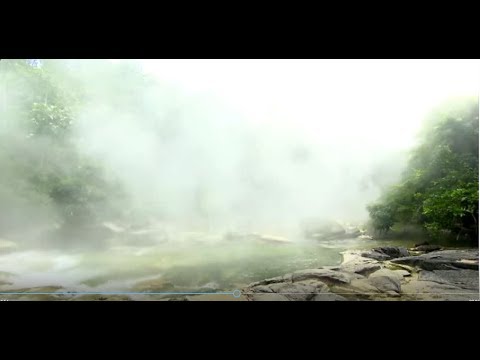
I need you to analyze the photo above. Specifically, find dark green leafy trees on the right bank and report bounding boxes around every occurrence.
[368,98,479,240]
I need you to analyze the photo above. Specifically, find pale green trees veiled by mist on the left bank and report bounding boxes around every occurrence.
[0,59,124,235]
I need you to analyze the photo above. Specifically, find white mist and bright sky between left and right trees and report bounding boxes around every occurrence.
[72,60,479,236]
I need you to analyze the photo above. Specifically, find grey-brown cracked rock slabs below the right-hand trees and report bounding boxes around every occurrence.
[186,247,479,301]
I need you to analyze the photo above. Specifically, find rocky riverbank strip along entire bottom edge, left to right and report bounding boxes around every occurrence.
[0,246,479,301]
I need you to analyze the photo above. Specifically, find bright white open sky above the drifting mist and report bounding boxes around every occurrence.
[137,59,480,149]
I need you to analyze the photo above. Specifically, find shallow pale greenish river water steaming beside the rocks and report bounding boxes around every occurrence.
[0,233,472,292]
